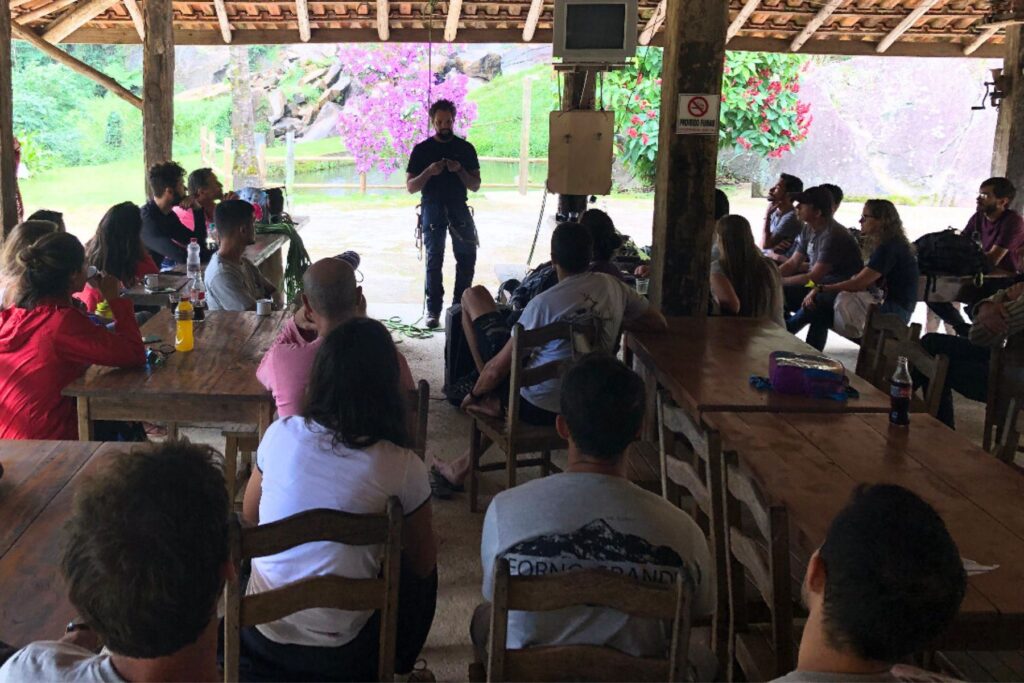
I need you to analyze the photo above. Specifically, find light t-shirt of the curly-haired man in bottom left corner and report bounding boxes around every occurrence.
[0,640,125,683]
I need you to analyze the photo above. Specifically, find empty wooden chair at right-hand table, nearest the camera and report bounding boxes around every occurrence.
[721,454,800,681]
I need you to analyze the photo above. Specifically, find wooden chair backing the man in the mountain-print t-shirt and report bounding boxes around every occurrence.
[487,558,690,681]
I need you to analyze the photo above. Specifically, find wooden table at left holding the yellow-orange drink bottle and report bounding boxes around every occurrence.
[63,309,287,441]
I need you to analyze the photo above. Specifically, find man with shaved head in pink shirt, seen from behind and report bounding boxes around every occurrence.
[256,258,416,418]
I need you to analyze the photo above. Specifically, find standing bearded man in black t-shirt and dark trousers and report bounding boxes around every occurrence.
[406,99,480,329]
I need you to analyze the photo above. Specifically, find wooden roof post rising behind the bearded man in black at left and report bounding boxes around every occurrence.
[142,0,174,189]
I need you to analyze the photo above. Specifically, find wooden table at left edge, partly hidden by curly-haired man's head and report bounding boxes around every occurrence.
[0,440,131,645]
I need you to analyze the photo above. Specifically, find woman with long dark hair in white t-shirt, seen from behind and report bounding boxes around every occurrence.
[241,321,437,681]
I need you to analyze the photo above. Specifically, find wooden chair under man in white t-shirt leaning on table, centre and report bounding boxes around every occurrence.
[469,322,597,512]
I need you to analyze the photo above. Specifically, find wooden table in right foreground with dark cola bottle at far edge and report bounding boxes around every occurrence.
[711,413,1024,650]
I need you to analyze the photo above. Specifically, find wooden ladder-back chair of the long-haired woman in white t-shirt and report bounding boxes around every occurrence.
[224,497,402,683]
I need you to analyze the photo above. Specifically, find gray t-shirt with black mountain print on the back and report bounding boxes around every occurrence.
[480,472,715,656]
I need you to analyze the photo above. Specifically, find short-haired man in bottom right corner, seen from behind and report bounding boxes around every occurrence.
[776,484,967,683]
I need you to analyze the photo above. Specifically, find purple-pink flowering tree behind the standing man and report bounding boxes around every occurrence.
[338,43,476,175]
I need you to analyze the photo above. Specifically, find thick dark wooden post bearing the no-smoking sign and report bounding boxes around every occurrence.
[650,0,729,315]
